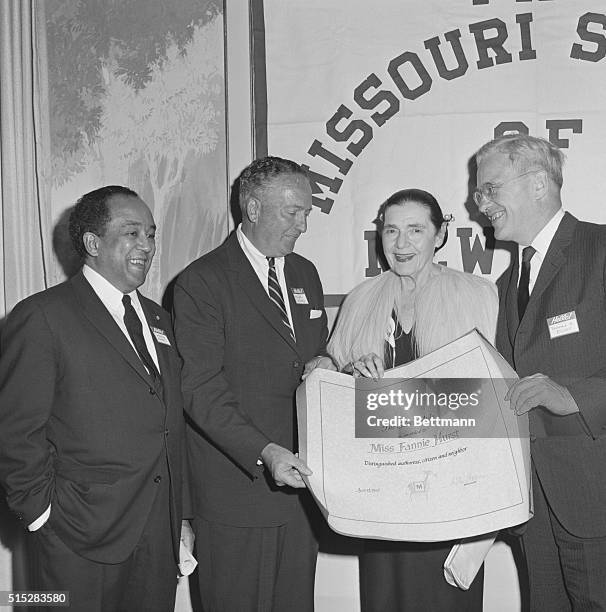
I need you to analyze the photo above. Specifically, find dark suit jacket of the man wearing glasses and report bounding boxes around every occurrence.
[497,213,606,537]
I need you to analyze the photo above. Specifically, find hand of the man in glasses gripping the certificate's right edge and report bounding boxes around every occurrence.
[505,374,579,416]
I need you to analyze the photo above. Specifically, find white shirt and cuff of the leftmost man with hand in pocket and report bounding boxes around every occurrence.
[27,264,160,531]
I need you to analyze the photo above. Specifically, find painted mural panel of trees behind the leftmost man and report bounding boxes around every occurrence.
[47,0,227,298]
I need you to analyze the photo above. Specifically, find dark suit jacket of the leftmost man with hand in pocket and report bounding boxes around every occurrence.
[0,273,183,563]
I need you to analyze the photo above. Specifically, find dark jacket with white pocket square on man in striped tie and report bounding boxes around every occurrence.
[174,232,327,526]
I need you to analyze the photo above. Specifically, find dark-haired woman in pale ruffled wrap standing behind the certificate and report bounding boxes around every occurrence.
[328,189,498,612]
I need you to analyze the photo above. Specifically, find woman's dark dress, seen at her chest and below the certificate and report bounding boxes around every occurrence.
[360,323,484,612]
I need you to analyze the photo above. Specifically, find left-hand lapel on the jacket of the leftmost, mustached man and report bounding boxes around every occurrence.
[71,272,156,385]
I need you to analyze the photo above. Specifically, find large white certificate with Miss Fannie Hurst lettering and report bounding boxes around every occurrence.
[297,331,531,541]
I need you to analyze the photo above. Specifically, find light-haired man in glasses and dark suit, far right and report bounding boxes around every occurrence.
[474,135,606,612]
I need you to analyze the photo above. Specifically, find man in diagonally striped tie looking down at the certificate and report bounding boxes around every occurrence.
[174,157,331,612]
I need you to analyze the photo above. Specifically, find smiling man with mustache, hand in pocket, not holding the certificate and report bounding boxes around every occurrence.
[0,186,190,612]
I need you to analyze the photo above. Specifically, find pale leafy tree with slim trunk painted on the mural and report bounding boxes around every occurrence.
[99,16,223,287]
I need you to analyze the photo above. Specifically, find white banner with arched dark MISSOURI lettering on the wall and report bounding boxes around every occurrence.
[264,0,606,305]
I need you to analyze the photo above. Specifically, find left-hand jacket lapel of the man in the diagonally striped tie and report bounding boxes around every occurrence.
[226,232,298,352]
